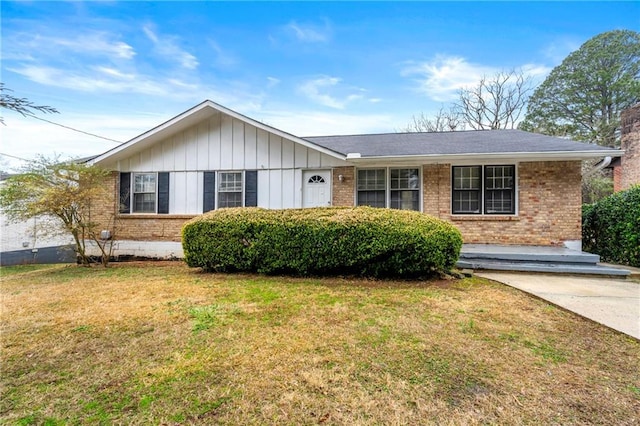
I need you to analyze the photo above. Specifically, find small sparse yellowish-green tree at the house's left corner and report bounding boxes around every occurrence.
[0,157,115,266]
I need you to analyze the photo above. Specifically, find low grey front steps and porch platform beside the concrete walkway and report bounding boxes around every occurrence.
[456,244,630,277]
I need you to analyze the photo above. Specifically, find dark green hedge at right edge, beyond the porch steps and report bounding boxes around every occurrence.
[582,185,640,267]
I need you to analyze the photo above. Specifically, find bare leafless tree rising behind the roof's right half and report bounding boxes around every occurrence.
[455,70,533,130]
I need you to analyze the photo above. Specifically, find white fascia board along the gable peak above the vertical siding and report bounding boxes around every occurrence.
[90,100,345,165]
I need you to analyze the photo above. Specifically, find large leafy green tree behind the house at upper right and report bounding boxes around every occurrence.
[520,30,640,146]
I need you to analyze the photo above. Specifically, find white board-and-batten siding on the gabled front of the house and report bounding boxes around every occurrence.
[117,112,346,214]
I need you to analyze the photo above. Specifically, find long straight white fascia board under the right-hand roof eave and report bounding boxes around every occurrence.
[347,149,624,165]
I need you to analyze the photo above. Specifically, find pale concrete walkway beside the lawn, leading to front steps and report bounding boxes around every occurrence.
[476,272,640,340]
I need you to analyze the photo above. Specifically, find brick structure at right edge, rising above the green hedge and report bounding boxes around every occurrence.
[620,104,640,190]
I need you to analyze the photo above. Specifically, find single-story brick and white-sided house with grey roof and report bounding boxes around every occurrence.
[91,101,622,257]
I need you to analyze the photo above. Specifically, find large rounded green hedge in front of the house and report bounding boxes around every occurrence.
[182,207,462,277]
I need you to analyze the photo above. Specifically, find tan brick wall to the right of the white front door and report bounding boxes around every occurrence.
[334,161,582,245]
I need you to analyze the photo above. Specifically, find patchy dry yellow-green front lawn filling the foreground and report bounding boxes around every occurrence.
[0,262,640,424]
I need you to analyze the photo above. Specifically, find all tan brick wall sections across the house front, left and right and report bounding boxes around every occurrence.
[98,161,582,245]
